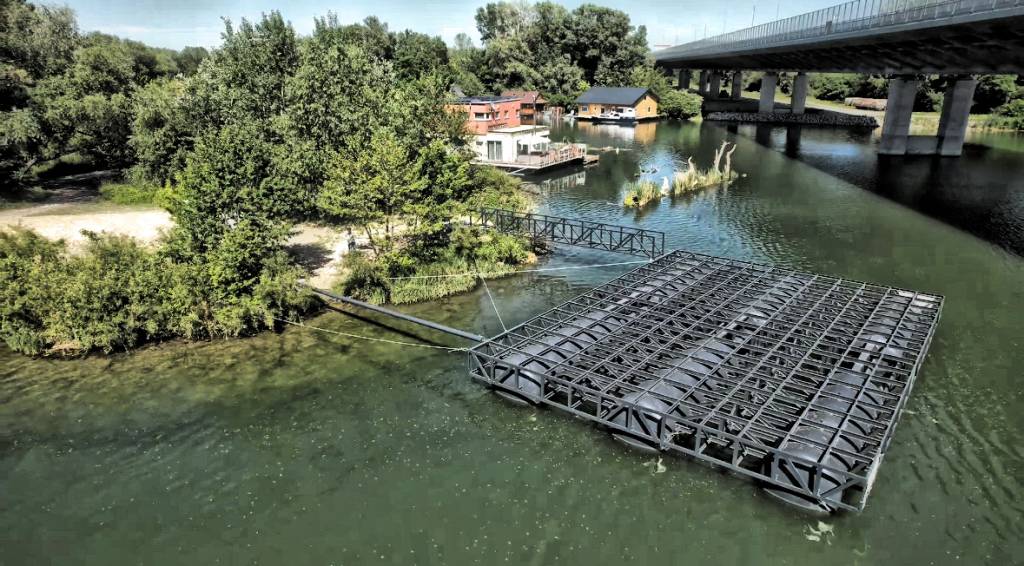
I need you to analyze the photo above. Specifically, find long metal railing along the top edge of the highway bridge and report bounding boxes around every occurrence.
[654,0,1024,59]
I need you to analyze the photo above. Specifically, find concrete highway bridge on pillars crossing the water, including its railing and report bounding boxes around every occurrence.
[654,0,1024,156]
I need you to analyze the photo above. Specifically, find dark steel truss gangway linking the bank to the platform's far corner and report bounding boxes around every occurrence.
[467,209,665,259]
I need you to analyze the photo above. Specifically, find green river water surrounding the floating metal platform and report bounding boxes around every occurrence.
[0,118,1024,564]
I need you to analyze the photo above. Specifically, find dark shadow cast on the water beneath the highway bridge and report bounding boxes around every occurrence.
[716,122,1024,256]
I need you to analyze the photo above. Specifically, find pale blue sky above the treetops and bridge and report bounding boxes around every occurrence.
[64,0,839,49]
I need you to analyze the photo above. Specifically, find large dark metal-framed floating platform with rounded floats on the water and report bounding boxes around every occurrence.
[470,251,942,512]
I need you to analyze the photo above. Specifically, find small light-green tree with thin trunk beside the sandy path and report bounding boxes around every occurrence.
[319,130,429,253]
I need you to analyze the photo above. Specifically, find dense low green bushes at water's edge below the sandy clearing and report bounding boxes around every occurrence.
[0,224,310,355]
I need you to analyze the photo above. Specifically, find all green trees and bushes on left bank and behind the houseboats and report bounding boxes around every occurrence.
[9,0,652,354]
